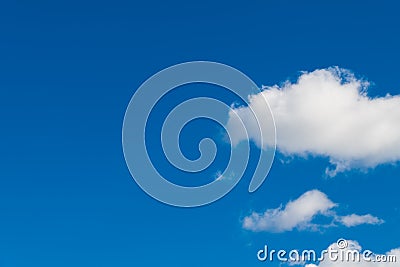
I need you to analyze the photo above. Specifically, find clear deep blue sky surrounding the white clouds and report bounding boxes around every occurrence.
[0,1,400,267]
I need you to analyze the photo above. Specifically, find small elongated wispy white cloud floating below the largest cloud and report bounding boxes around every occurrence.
[242,190,383,232]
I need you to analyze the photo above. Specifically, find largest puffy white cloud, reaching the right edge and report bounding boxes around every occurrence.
[227,68,400,176]
